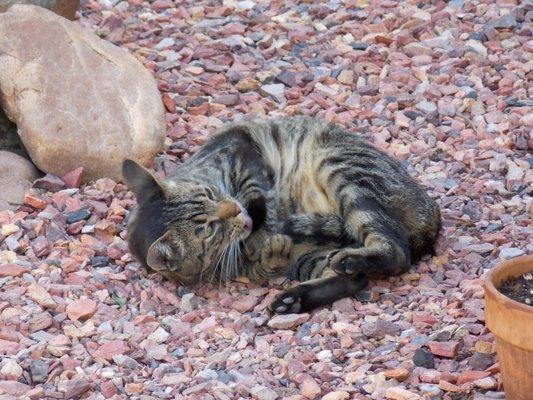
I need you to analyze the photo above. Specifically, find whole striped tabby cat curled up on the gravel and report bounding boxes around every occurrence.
[123,117,440,313]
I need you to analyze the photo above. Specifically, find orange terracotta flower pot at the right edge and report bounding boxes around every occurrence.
[485,255,533,400]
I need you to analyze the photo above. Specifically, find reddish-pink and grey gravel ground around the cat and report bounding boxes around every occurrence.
[0,0,533,400]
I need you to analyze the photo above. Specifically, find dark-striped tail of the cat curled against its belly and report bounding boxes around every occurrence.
[280,213,351,245]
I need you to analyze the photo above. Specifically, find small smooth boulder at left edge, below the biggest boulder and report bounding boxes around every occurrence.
[0,151,39,210]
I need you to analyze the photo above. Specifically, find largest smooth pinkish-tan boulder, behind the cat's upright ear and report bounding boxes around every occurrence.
[0,4,165,180]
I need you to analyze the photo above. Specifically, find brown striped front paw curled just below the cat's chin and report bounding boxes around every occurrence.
[244,232,293,281]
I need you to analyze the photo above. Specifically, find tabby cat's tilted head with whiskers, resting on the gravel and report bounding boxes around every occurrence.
[122,160,252,285]
